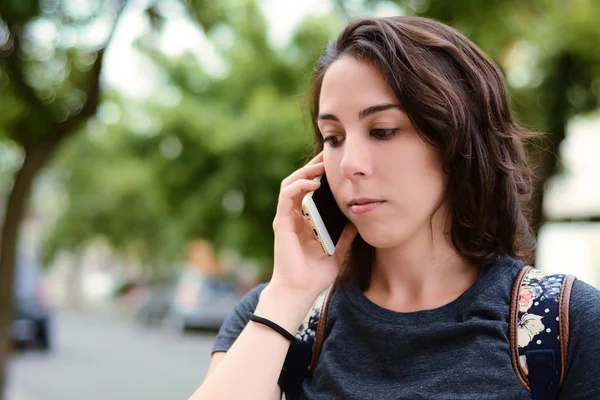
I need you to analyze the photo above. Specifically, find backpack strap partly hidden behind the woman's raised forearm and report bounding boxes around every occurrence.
[278,285,335,400]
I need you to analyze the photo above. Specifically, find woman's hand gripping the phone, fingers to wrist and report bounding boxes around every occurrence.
[269,153,356,304]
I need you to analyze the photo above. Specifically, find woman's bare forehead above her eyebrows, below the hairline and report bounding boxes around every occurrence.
[319,56,398,113]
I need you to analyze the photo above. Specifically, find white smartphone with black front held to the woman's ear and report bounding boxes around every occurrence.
[302,175,348,256]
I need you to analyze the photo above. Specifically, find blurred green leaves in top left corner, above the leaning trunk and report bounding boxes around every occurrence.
[0,0,124,148]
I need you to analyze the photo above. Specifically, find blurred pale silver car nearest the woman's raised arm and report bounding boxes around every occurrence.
[164,269,242,332]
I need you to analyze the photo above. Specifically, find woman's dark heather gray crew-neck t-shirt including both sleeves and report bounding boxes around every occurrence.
[213,257,600,400]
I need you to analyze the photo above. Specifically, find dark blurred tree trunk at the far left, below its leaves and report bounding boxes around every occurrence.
[0,145,56,400]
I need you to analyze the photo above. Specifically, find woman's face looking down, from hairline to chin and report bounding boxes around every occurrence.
[317,56,446,248]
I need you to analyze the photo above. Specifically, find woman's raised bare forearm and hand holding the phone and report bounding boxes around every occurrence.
[191,154,357,400]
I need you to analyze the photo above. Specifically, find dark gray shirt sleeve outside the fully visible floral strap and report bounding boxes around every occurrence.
[560,280,600,400]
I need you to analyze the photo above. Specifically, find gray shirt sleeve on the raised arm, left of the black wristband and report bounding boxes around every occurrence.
[212,283,267,354]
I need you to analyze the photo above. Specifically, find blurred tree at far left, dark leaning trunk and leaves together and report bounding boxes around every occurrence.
[0,0,123,396]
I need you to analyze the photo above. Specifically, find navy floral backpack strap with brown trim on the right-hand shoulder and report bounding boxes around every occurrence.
[509,266,576,400]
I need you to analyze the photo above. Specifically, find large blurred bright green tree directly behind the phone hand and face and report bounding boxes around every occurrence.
[46,1,333,269]
